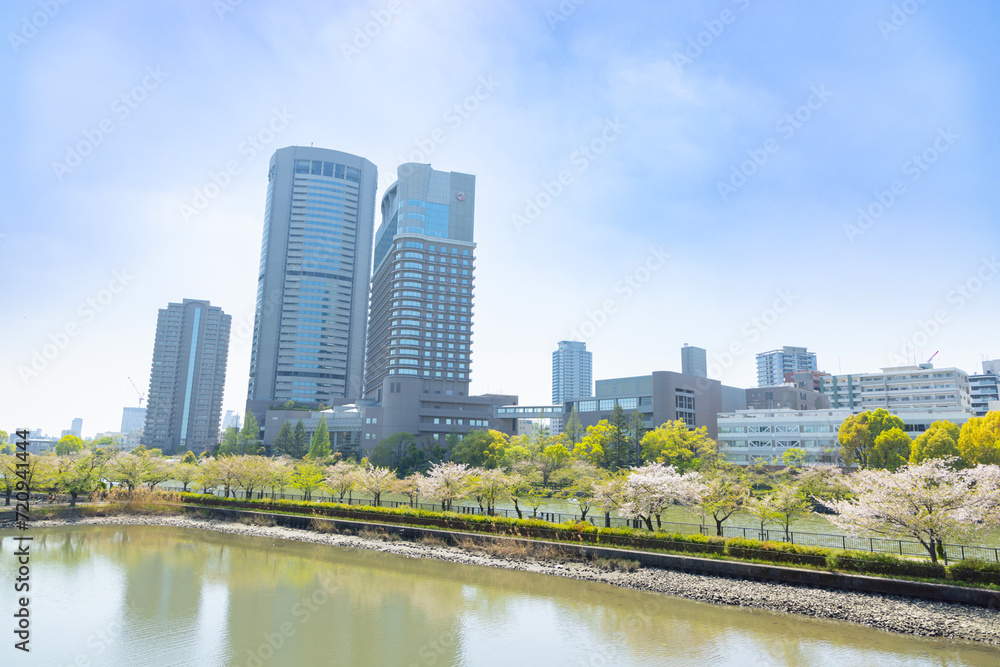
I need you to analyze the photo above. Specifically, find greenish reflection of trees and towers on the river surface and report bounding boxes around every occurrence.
[13,526,984,665]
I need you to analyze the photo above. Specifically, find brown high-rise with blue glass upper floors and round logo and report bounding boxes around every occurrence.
[365,163,476,401]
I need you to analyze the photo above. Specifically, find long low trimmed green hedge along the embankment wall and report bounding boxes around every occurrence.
[178,493,1000,584]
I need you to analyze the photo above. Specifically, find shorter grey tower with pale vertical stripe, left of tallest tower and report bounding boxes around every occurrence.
[143,299,232,454]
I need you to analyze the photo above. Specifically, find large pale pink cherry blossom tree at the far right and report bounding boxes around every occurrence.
[817,459,1000,563]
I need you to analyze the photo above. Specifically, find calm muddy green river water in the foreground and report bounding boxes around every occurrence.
[0,526,1000,667]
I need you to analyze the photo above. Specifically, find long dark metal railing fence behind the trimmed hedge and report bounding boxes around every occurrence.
[170,492,1000,563]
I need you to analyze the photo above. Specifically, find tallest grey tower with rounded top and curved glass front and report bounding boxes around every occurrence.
[247,146,377,422]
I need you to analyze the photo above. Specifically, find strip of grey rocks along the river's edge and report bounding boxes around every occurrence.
[23,516,1000,646]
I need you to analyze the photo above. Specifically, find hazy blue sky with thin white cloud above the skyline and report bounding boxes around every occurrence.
[0,0,1000,435]
